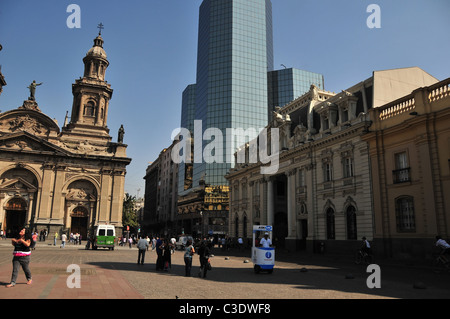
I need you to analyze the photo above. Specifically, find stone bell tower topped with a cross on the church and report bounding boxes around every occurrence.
[62,25,113,142]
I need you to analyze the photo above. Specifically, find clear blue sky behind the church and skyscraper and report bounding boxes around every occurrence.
[0,0,450,196]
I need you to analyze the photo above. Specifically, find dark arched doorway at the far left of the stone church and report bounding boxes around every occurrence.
[4,197,27,237]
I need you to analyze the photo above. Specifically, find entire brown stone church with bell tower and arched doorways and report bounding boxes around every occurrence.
[0,34,131,238]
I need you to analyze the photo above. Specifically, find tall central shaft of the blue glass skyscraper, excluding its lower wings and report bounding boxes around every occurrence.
[193,0,273,187]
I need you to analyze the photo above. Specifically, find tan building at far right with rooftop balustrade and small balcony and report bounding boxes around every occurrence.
[363,78,450,259]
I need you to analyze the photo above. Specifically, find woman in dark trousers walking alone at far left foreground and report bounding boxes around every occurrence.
[6,228,32,288]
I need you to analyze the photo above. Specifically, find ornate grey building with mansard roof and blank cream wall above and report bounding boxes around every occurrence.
[226,67,437,252]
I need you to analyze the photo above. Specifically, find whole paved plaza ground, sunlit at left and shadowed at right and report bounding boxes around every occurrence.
[0,240,450,300]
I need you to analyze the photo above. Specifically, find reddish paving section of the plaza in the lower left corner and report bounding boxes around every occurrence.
[0,246,143,299]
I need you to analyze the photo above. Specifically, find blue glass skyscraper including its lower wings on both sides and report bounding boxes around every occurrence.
[178,0,324,194]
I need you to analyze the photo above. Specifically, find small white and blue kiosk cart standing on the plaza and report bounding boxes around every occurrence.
[252,225,275,274]
